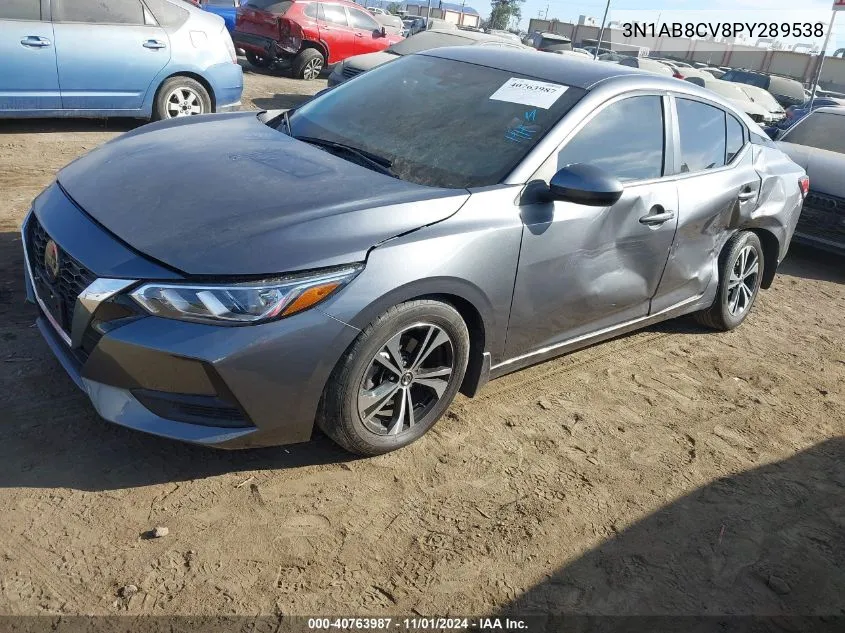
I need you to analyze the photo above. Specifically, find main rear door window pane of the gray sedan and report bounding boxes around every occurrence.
[675,99,725,173]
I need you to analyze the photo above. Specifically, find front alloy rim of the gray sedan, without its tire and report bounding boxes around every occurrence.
[358,323,455,435]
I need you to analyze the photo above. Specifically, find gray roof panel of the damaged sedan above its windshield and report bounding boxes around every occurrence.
[417,46,652,89]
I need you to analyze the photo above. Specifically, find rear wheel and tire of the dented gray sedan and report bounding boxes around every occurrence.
[693,231,765,332]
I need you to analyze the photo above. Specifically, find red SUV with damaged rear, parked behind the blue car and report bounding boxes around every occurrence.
[232,0,402,79]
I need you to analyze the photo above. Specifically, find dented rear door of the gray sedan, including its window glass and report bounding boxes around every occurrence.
[652,96,761,312]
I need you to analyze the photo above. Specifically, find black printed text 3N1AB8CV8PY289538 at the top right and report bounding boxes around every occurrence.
[622,22,825,38]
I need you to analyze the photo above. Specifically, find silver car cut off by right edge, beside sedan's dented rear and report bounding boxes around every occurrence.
[777,107,845,255]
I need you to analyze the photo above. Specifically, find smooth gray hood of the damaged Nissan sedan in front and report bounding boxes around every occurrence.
[58,112,469,276]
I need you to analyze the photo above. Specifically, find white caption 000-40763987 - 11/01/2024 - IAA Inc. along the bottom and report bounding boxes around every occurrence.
[308,617,528,631]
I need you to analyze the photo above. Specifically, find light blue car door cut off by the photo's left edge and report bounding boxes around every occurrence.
[0,0,62,112]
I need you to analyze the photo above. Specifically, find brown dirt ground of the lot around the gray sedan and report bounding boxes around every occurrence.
[0,66,845,615]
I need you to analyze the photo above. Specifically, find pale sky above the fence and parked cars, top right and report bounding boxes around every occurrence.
[516,0,845,54]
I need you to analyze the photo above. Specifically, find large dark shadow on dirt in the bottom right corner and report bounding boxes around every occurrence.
[501,438,845,631]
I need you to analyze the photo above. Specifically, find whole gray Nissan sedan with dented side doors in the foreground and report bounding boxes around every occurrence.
[22,46,807,455]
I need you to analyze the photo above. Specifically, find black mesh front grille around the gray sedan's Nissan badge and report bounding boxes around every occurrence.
[26,215,96,336]
